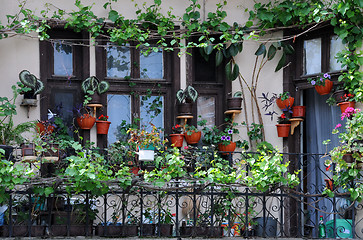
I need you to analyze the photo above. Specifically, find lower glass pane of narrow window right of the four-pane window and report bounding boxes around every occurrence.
[197,96,216,130]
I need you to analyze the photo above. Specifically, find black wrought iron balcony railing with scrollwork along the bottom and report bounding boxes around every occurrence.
[0,153,363,238]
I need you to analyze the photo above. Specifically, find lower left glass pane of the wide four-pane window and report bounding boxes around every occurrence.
[107,94,131,144]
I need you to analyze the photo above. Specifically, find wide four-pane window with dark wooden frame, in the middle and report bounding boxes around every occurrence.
[96,40,180,144]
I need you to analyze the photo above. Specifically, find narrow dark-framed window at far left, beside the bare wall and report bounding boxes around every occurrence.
[39,28,89,139]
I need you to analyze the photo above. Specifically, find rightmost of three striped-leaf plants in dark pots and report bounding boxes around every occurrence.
[176,85,198,116]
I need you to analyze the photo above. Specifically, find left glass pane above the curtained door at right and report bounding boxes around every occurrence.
[304,38,321,75]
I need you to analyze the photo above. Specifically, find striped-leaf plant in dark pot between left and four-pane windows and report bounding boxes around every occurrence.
[81,76,110,105]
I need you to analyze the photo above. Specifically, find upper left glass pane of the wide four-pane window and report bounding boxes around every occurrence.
[107,45,131,78]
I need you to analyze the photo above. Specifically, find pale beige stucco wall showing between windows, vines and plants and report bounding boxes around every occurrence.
[0,0,282,150]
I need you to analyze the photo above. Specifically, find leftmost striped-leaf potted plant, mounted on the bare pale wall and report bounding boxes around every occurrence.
[18,70,44,103]
